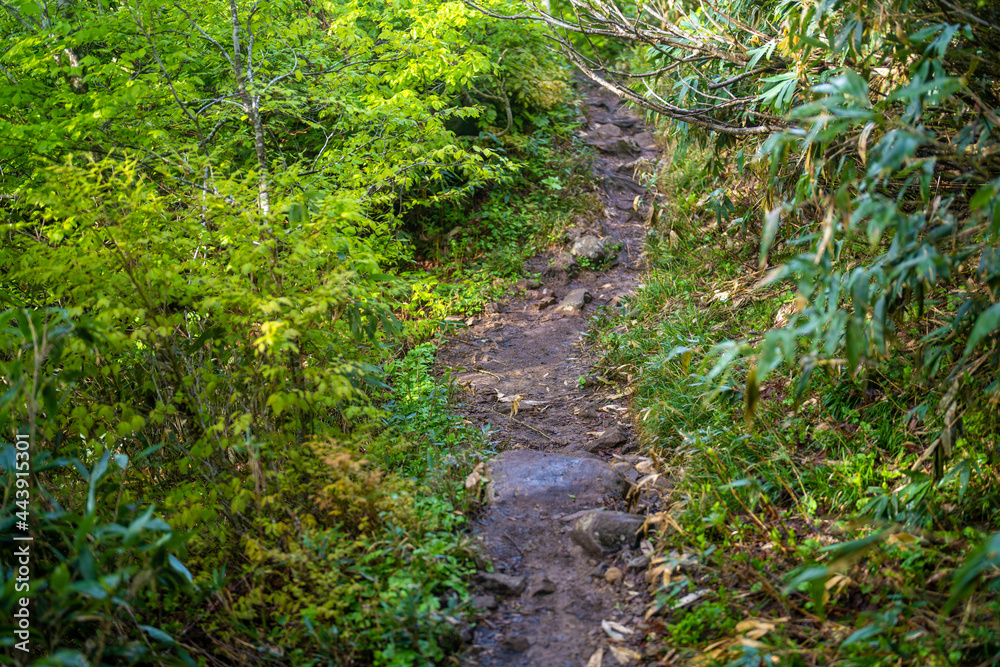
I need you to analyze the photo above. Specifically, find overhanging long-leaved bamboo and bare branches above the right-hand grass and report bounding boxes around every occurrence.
[547,0,1000,418]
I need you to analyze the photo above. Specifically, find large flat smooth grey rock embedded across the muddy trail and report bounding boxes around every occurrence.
[486,449,628,504]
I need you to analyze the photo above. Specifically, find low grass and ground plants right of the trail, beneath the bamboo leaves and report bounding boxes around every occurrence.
[594,152,1000,665]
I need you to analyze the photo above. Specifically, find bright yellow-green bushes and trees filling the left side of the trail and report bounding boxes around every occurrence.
[0,0,566,665]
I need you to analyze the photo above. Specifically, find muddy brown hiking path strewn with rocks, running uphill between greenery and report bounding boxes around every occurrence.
[438,87,672,667]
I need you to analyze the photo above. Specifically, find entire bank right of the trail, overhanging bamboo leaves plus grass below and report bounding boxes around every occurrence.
[572,0,1000,665]
